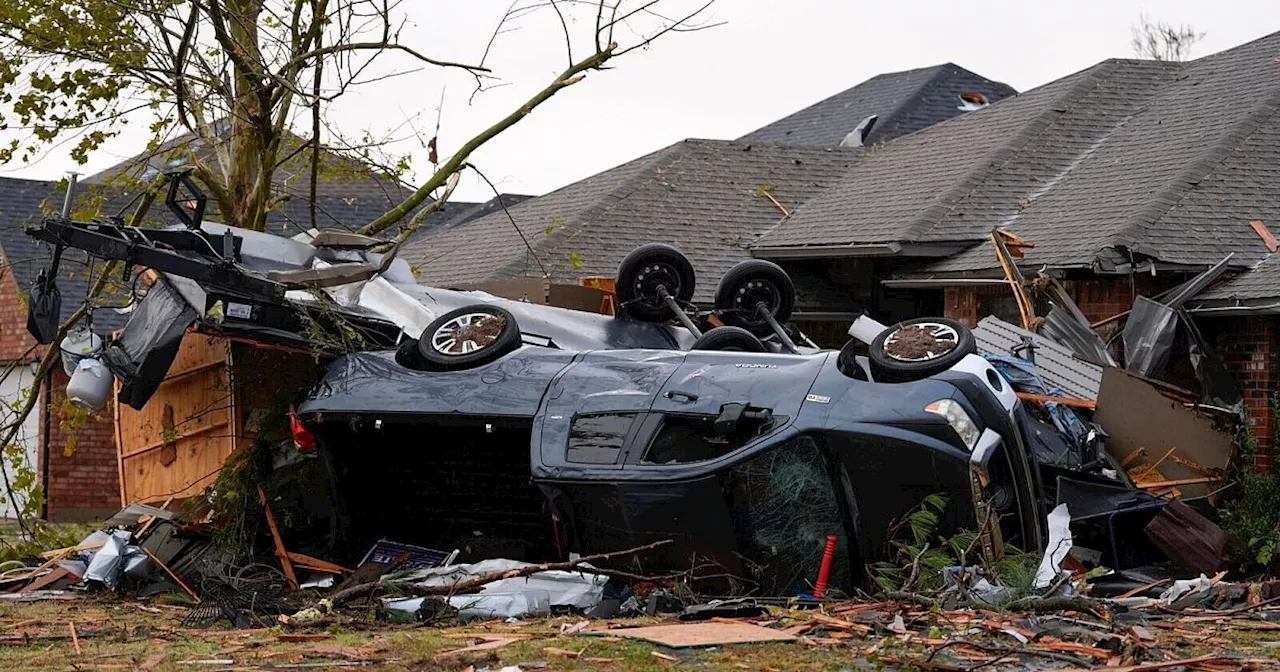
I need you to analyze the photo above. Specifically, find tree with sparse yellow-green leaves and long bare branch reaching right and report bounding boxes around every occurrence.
[0,0,709,233]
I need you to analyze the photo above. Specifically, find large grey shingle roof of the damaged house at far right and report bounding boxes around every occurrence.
[756,28,1280,279]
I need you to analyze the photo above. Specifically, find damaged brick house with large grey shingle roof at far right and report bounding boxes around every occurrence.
[751,33,1280,467]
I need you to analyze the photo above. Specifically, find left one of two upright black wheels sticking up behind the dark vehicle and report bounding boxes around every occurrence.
[614,243,695,323]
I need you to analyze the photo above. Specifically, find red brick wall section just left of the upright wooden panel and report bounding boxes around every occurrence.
[41,366,120,522]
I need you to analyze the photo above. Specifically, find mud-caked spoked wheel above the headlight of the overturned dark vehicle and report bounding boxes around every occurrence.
[868,317,978,383]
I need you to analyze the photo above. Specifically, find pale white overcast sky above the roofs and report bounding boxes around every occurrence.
[0,0,1280,200]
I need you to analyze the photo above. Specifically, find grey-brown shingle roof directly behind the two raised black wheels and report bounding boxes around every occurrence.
[401,140,855,301]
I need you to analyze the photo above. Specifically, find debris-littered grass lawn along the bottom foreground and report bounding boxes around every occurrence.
[0,595,1280,672]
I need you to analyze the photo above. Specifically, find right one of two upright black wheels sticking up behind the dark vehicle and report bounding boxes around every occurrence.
[716,259,796,337]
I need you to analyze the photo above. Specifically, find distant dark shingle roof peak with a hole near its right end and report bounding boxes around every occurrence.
[739,63,1016,147]
